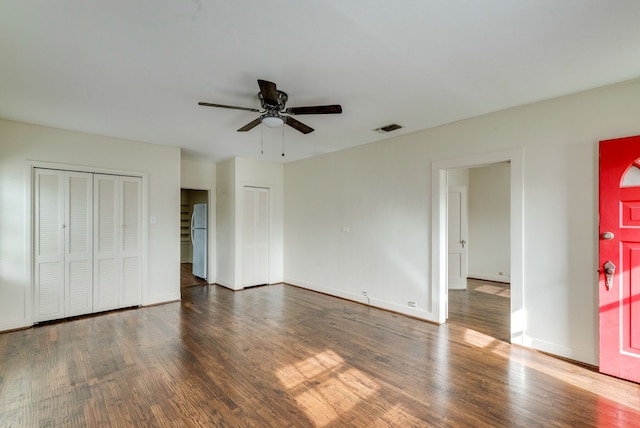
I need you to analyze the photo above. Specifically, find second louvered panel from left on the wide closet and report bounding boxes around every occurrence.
[65,172,93,317]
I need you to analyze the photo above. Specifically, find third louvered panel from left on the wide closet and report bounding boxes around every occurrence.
[93,174,120,312]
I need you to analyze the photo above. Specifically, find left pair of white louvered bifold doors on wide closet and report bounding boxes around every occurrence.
[34,169,93,322]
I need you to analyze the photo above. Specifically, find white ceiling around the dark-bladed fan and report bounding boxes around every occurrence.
[0,0,640,161]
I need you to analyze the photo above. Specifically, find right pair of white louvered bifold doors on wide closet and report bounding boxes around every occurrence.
[94,174,142,312]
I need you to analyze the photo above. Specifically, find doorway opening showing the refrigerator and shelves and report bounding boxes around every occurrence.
[180,189,210,289]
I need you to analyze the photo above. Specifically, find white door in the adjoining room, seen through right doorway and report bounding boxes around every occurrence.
[447,186,469,290]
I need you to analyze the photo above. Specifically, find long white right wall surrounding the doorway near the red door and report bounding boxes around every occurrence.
[284,80,640,364]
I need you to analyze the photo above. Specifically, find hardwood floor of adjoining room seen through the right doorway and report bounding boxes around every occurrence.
[449,279,511,342]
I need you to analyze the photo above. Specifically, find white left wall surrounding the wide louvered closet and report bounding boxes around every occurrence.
[0,120,180,330]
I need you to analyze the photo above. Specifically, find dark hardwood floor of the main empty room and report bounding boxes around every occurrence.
[0,285,640,427]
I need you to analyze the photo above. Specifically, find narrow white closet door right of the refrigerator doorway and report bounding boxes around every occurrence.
[242,187,269,287]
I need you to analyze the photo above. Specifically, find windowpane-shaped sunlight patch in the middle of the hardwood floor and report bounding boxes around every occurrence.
[276,350,380,427]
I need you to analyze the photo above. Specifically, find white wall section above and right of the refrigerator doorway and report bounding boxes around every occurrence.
[180,159,217,283]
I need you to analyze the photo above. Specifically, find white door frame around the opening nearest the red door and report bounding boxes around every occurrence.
[431,149,527,345]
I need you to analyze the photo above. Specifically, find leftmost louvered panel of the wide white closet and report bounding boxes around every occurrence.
[34,169,64,322]
